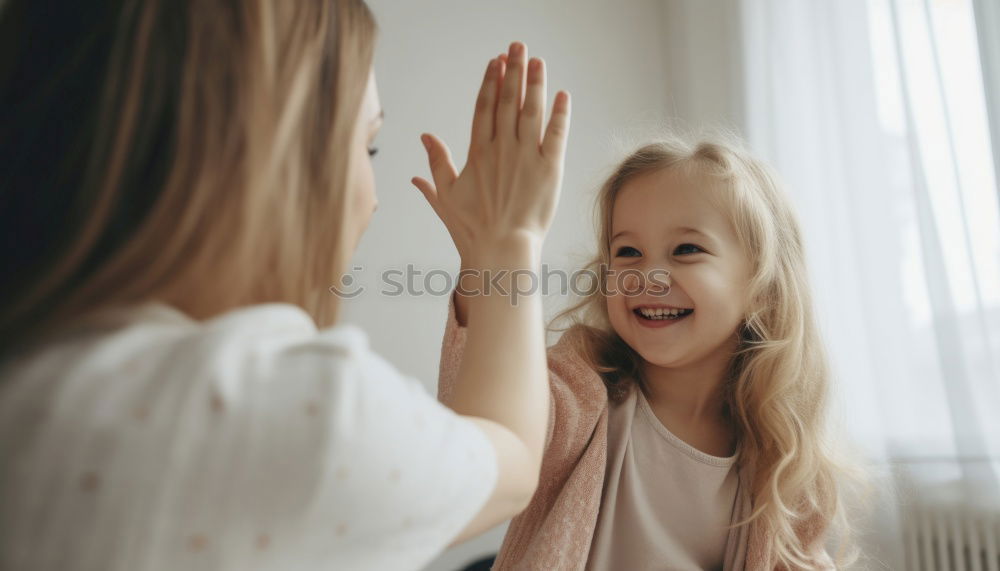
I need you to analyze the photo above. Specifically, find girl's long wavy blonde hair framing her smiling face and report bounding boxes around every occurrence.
[550,134,865,569]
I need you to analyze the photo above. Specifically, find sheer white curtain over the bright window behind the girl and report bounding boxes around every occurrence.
[742,0,1000,570]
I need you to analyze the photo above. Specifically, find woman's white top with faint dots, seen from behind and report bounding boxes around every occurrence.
[0,303,497,571]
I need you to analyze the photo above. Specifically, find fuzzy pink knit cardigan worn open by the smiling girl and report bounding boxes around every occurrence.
[438,298,835,571]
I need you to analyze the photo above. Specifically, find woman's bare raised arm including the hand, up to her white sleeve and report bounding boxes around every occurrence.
[413,47,569,540]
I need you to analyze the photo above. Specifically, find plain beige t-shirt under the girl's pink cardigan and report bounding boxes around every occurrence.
[587,390,739,571]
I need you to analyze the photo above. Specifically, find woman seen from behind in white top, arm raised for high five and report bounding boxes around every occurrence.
[0,0,569,571]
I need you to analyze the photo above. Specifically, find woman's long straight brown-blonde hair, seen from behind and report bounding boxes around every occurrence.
[0,0,376,352]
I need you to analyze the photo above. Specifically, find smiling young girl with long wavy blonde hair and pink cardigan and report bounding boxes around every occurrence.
[439,135,864,571]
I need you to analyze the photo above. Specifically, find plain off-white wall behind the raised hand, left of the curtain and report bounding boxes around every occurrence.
[345,0,739,571]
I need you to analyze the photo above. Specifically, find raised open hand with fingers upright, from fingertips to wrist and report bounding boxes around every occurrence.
[412,42,570,260]
